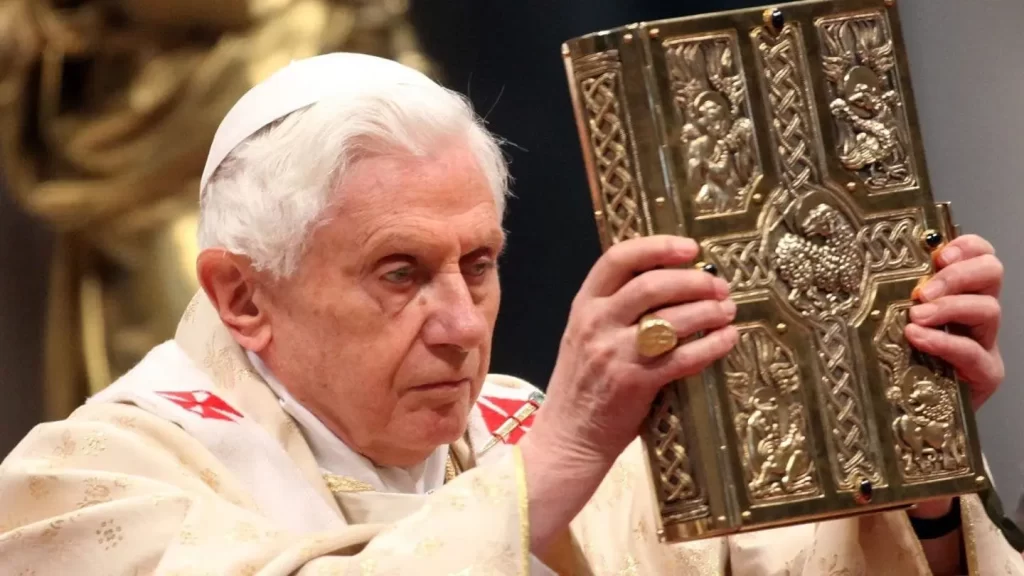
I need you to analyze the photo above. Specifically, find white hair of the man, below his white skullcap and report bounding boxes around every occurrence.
[199,85,508,278]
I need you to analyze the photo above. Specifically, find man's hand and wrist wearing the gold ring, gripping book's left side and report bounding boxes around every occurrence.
[520,236,738,554]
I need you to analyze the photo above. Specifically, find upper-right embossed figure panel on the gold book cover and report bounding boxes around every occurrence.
[818,13,915,192]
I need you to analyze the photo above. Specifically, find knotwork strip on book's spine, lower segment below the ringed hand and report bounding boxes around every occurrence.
[646,387,709,520]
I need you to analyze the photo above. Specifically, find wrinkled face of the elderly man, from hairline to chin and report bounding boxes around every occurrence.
[263,140,504,466]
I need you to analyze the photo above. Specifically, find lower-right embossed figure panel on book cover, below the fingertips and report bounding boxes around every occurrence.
[874,302,971,482]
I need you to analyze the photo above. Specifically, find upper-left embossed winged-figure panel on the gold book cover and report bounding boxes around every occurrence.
[665,34,762,217]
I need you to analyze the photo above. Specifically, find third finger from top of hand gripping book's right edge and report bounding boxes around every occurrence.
[910,294,1001,349]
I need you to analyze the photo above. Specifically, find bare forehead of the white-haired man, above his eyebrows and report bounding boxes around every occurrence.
[333,146,501,245]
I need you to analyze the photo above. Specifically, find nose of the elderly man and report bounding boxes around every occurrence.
[423,273,489,351]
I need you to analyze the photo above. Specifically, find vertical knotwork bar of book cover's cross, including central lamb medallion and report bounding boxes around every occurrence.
[751,24,882,491]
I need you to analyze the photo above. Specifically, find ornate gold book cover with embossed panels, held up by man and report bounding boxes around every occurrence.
[563,0,987,541]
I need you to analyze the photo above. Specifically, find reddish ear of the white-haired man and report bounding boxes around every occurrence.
[196,248,272,353]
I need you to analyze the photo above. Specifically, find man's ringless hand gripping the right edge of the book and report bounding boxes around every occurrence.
[905,230,1006,410]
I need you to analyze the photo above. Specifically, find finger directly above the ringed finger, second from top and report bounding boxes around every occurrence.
[608,269,729,324]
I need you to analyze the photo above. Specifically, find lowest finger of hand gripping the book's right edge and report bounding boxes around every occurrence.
[905,324,1005,397]
